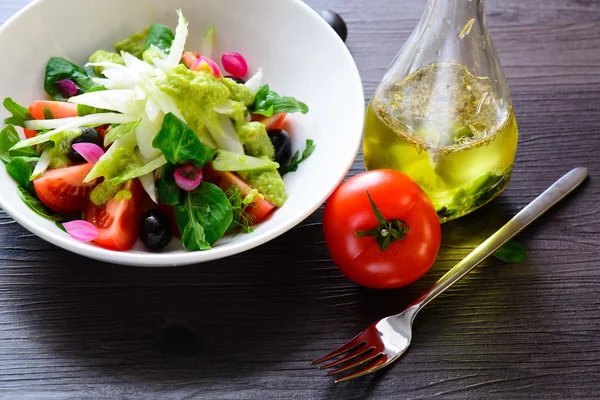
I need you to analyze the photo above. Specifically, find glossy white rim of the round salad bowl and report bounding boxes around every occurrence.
[0,0,365,267]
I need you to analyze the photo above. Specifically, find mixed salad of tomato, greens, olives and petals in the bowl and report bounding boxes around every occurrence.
[0,11,315,251]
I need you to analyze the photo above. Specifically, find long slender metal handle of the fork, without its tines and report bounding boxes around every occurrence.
[407,167,588,317]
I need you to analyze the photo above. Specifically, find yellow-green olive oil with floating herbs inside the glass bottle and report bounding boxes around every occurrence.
[364,63,518,221]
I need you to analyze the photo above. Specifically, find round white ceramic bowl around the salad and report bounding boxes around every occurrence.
[0,0,364,266]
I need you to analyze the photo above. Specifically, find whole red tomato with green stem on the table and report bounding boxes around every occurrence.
[323,170,441,289]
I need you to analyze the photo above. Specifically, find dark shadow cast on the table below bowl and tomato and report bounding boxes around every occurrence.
[10,194,544,394]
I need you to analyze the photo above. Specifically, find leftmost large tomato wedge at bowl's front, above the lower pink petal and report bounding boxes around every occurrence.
[33,163,98,214]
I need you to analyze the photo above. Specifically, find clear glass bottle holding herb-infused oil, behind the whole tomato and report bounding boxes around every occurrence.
[364,0,518,222]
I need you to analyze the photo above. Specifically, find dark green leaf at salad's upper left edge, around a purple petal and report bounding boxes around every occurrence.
[44,57,98,101]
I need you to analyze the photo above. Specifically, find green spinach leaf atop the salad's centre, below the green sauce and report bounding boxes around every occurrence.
[152,113,214,168]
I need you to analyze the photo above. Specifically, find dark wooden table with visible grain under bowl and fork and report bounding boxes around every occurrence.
[0,0,600,399]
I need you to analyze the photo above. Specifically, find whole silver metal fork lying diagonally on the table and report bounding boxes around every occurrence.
[313,168,588,383]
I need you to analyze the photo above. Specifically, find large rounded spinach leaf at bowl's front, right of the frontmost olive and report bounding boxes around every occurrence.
[175,182,233,251]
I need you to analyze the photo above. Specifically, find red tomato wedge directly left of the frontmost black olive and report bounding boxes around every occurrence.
[85,179,144,251]
